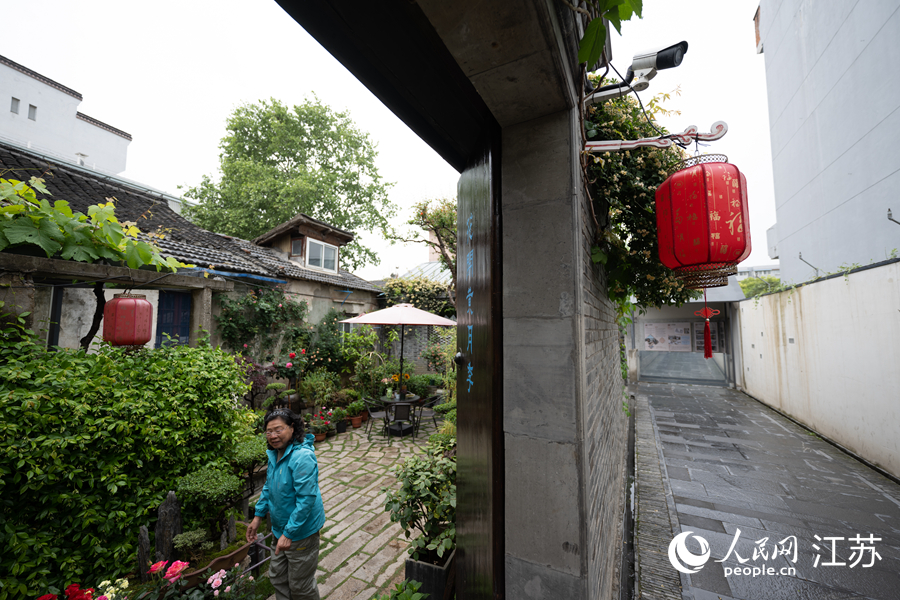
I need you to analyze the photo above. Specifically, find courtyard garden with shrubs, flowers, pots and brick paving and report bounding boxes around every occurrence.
[0,289,456,600]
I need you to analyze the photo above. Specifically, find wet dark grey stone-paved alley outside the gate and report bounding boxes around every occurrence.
[629,383,900,600]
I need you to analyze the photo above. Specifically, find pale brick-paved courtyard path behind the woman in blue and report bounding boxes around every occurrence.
[262,419,435,600]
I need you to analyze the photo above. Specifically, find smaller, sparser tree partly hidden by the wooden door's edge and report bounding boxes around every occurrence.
[387,198,456,306]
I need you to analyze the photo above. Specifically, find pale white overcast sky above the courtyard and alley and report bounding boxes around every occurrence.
[0,0,775,279]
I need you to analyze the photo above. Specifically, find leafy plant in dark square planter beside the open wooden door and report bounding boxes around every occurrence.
[382,436,456,598]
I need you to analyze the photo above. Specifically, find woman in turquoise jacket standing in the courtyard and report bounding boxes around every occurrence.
[247,408,325,600]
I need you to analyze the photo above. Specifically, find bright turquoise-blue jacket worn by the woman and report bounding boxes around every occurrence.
[255,434,325,541]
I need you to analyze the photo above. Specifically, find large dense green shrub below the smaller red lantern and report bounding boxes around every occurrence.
[0,316,252,600]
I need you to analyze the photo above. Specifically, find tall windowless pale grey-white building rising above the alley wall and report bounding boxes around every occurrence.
[756,0,900,283]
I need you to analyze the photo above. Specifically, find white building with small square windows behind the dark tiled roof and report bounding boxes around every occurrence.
[0,56,131,174]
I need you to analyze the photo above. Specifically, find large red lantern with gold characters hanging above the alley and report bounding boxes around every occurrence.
[656,154,750,289]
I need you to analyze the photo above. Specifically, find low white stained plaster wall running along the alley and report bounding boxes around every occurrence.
[737,262,900,475]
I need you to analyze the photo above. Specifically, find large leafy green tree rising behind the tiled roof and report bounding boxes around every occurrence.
[184,97,397,269]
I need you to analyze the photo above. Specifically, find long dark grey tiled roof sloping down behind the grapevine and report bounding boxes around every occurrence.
[0,142,380,292]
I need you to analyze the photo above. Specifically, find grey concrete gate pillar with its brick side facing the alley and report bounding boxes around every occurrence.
[502,106,628,599]
